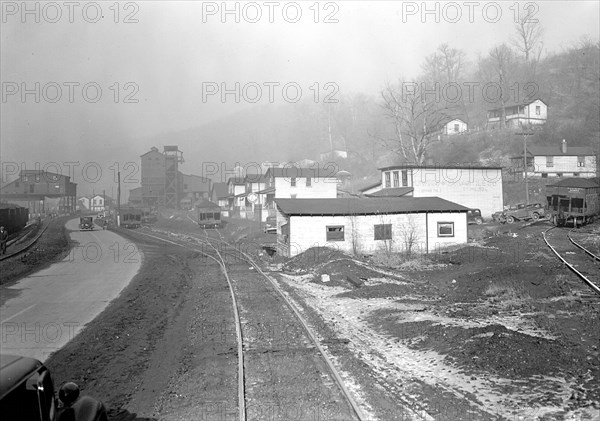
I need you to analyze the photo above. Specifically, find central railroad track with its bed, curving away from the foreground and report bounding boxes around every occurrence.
[129,226,366,421]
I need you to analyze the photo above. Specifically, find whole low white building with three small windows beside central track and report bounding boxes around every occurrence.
[275,197,468,257]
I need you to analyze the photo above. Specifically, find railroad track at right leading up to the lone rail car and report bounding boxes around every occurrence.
[542,227,600,298]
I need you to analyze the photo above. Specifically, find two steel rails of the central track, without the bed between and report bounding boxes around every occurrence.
[129,226,366,421]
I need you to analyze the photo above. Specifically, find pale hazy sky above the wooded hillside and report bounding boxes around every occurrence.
[0,1,600,194]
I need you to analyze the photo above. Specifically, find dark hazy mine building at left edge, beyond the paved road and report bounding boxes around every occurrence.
[0,170,77,216]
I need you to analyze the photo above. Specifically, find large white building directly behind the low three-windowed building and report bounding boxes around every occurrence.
[361,164,504,217]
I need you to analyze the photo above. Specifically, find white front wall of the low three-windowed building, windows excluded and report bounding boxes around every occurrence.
[277,213,467,257]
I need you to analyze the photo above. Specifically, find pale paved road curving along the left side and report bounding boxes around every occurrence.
[0,219,143,361]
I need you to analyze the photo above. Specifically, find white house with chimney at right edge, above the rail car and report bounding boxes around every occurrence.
[511,139,598,178]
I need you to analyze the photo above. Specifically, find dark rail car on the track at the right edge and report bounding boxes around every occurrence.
[546,178,600,227]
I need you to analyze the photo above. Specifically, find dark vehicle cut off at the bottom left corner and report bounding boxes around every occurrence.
[0,354,107,421]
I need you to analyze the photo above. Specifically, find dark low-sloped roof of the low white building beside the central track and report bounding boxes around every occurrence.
[275,197,469,215]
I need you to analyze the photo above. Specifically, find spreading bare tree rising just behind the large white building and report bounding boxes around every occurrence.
[372,81,447,164]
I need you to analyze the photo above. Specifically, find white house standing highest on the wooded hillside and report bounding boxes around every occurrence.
[487,99,548,129]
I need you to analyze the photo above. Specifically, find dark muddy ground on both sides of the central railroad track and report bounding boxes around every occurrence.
[4,216,600,420]
